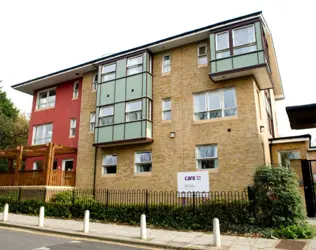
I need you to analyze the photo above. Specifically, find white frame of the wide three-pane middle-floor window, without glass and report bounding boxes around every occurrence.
[193,87,238,121]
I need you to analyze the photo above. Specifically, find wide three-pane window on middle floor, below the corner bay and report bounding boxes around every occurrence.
[194,88,237,120]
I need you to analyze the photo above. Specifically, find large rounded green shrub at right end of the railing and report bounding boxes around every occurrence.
[253,166,305,227]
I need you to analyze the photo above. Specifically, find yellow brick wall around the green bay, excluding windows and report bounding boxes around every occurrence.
[77,43,269,191]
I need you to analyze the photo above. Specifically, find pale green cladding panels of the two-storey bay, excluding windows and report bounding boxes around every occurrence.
[95,52,152,143]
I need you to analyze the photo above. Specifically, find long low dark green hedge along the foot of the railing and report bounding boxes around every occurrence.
[0,198,252,232]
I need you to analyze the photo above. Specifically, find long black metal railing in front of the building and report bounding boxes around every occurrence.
[0,187,253,210]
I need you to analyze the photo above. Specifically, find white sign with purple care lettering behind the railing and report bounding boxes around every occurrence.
[178,171,210,192]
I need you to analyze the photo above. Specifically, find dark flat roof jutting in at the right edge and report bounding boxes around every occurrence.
[286,103,316,129]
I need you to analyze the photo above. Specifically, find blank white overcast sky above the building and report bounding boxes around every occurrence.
[0,0,316,141]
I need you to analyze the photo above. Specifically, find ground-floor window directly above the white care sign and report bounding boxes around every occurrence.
[196,145,218,169]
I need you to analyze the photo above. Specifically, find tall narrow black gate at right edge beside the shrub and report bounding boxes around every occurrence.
[301,160,316,217]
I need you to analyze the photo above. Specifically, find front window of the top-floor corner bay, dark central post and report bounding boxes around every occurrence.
[215,25,257,59]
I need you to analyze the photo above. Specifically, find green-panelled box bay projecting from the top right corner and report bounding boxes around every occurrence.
[210,20,274,89]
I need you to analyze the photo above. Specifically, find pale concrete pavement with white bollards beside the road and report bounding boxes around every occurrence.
[0,214,316,250]
